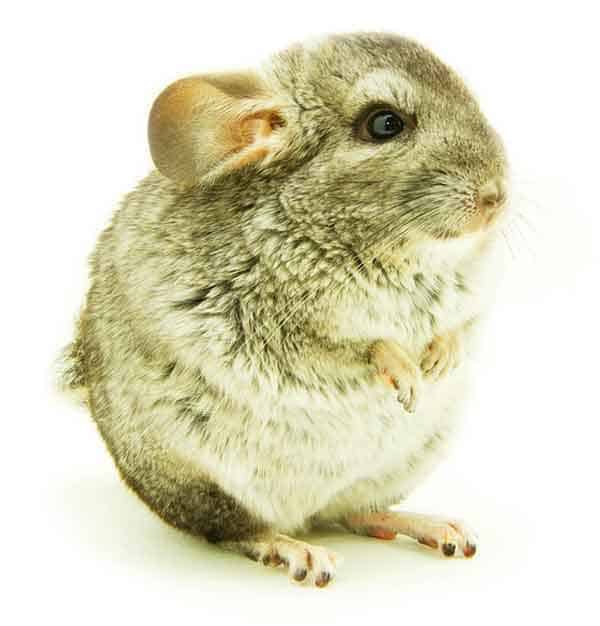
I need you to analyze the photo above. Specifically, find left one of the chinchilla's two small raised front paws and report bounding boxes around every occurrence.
[371,341,422,413]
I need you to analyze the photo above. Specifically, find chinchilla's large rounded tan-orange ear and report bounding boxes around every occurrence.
[148,72,284,185]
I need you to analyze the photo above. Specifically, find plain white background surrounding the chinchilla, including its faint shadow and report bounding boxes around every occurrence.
[0,0,600,624]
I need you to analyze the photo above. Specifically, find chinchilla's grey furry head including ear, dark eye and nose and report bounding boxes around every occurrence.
[149,34,507,254]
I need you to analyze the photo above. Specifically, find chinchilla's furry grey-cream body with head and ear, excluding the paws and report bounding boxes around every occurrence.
[65,34,506,556]
